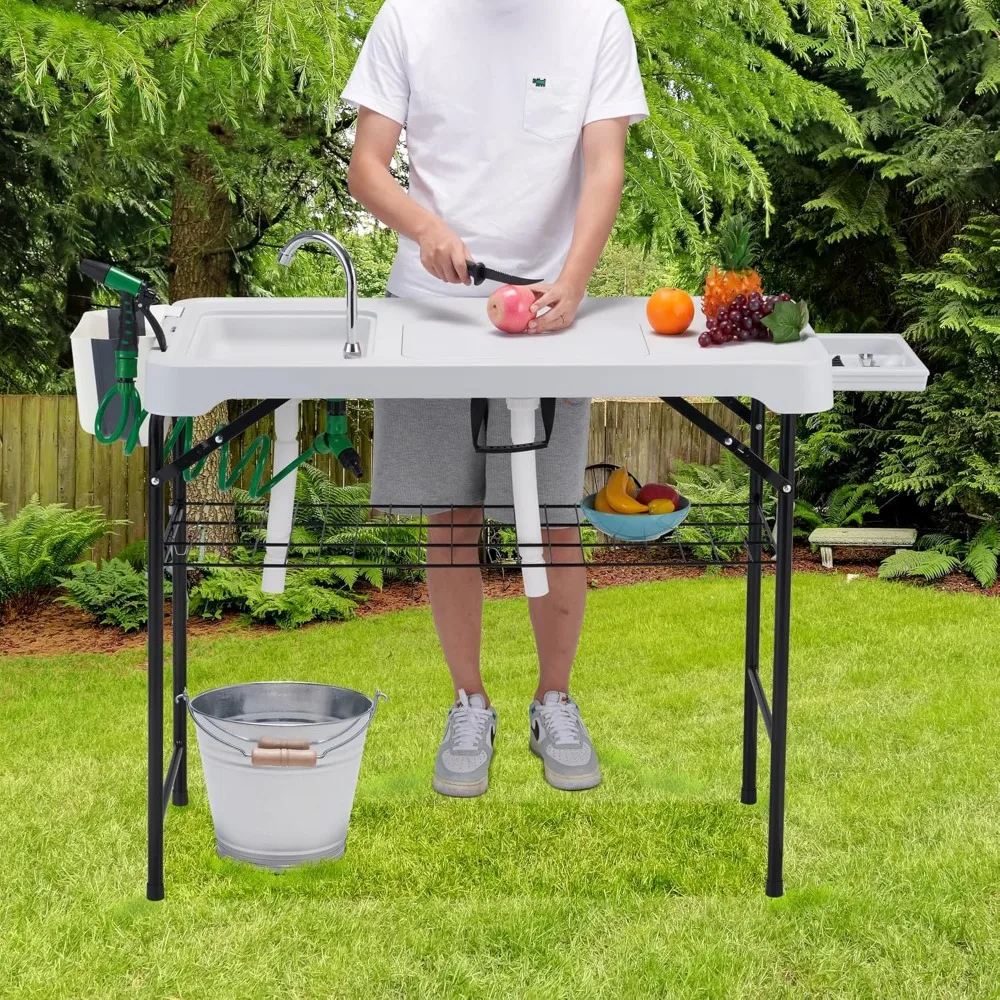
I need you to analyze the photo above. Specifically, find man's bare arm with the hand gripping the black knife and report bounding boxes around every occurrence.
[347,108,470,285]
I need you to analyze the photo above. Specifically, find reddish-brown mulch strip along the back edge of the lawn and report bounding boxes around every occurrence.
[0,545,1000,656]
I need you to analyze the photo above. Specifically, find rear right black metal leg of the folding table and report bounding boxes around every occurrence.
[740,399,765,806]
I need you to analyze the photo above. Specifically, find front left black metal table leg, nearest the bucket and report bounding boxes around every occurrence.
[146,414,165,900]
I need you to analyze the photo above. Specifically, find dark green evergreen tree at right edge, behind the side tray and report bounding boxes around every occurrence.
[761,0,1000,533]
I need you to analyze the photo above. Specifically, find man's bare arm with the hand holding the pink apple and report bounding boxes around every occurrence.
[528,118,629,333]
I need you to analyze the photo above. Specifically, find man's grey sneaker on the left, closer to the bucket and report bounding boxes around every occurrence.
[431,689,497,798]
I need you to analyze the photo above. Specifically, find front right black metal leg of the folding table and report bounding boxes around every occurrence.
[765,414,796,896]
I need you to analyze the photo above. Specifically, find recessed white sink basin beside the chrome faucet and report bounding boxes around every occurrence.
[187,306,375,365]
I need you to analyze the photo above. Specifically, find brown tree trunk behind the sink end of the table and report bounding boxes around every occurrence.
[170,151,235,552]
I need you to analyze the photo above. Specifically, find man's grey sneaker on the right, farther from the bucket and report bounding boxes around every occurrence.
[528,691,601,792]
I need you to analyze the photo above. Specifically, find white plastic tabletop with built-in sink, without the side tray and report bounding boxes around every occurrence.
[143,298,833,416]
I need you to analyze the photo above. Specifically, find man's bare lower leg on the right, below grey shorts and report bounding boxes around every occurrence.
[528,528,587,701]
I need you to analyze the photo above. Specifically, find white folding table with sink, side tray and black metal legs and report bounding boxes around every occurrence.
[90,298,927,899]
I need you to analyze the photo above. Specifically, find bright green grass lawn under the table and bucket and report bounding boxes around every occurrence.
[0,575,1000,1000]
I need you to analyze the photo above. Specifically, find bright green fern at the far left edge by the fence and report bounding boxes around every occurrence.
[0,496,115,610]
